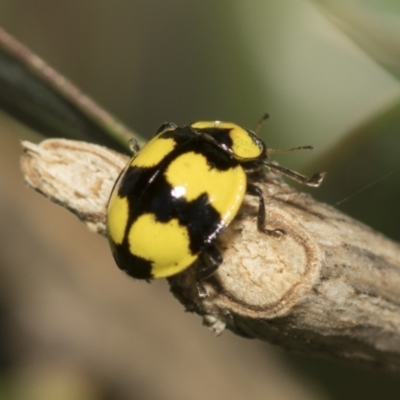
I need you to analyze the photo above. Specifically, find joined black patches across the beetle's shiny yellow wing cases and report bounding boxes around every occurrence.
[114,127,247,279]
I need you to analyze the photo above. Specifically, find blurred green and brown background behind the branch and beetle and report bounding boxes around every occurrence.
[0,0,400,400]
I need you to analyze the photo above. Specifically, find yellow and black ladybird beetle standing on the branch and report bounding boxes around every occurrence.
[107,118,323,295]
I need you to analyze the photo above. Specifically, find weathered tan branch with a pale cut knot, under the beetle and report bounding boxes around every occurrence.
[21,139,400,370]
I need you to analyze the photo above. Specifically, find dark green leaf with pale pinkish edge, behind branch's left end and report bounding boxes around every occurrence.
[0,27,137,151]
